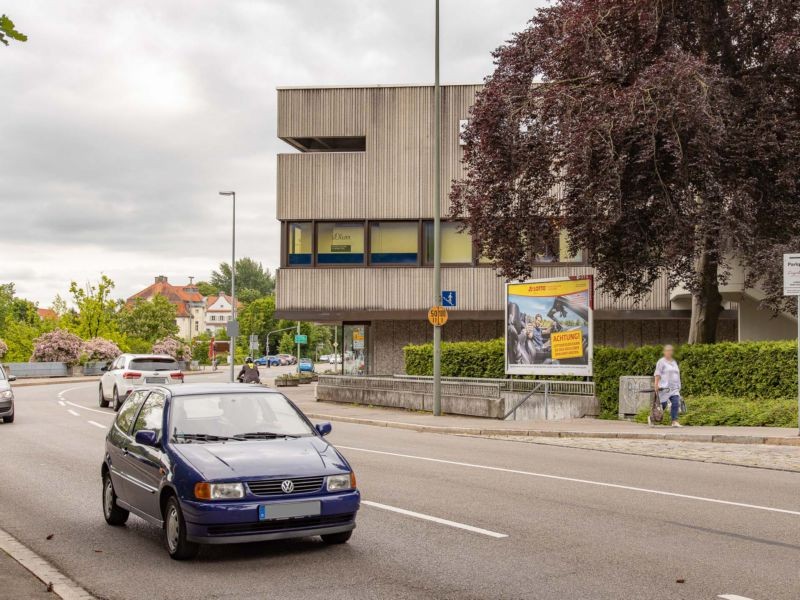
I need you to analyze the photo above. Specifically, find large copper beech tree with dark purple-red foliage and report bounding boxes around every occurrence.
[452,0,800,342]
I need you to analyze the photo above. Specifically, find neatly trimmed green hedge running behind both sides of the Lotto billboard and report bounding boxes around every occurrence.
[403,339,797,418]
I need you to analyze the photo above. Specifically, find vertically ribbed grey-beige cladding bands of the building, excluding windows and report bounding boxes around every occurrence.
[277,85,670,320]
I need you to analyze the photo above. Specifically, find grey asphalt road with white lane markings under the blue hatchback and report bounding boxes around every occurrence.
[0,379,800,600]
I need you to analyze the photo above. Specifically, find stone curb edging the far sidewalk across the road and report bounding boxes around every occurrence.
[306,412,800,447]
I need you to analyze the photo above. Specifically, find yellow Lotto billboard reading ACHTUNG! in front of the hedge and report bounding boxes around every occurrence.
[506,276,593,376]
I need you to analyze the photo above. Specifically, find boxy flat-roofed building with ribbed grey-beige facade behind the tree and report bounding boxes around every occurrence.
[276,85,795,374]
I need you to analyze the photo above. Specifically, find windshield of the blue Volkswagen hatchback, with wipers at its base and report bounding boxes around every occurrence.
[170,393,313,443]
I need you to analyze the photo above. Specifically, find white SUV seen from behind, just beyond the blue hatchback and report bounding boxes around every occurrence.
[98,354,183,410]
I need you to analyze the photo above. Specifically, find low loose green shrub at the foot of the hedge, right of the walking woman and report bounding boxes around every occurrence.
[635,395,797,427]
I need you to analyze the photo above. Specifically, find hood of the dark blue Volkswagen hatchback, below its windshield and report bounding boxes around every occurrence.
[172,436,350,481]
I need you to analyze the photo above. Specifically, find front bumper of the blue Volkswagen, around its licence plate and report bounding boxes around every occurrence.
[181,490,361,544]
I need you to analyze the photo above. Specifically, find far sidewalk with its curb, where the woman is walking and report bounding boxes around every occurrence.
[280,381,800,447]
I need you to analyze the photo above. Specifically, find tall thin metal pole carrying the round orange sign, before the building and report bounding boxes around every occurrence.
[433,0,442,417]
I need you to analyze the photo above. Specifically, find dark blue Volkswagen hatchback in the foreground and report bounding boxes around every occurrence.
[101,384,360,560]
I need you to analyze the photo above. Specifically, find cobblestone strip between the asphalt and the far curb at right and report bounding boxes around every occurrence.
[480,435,800,473]
